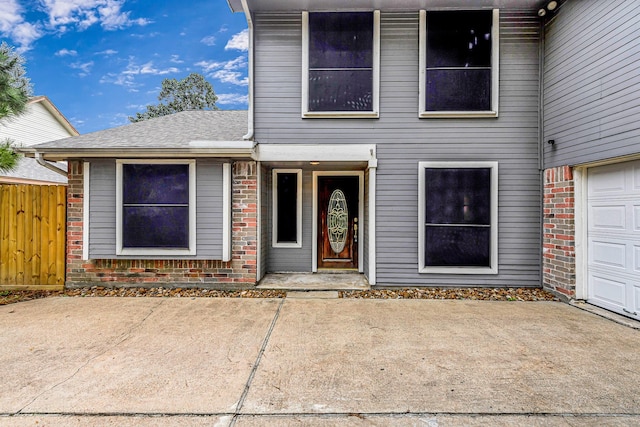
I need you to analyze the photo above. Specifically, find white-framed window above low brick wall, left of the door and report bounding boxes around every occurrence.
[116,160,196,255]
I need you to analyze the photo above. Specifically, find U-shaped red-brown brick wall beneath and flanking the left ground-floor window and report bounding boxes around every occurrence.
[66,161,258,289]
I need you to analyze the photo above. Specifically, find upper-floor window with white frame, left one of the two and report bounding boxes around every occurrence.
[302,11,380,117]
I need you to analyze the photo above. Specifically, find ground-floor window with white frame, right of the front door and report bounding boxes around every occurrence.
[418,162,498,274]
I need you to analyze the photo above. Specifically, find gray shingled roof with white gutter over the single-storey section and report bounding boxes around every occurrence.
[20,110,253,160]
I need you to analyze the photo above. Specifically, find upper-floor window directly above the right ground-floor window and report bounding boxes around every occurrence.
[420,9,499,117]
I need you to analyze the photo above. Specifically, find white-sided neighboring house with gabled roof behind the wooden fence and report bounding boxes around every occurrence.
[0,96,79,184]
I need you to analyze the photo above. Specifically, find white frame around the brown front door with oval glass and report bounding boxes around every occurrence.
[311,171,362,273]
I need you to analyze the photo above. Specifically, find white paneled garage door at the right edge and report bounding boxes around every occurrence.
[587,161,640,319]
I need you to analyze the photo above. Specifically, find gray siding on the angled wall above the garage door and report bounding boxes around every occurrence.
[544,0,640,167]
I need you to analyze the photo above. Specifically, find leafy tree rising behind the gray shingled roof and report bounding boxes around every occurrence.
[129,73,218,123]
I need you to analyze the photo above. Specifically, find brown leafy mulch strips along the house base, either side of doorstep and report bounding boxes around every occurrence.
[0,286,558,305]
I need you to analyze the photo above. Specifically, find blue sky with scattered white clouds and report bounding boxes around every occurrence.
[0,0,248,133]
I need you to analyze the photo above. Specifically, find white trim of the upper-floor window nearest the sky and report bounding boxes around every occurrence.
[302,10,380,118]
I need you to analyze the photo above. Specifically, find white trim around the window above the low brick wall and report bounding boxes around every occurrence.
[116,159,196,257]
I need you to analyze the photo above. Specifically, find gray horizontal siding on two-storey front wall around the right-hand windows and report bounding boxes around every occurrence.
[255,11,541,286]
